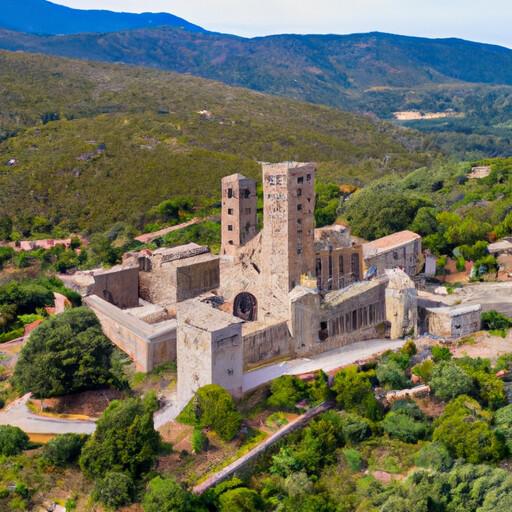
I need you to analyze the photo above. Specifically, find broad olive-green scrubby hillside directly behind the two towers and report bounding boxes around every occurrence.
[0,52,432,235]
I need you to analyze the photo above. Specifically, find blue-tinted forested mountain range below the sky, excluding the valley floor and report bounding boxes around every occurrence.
[0,27,512,107]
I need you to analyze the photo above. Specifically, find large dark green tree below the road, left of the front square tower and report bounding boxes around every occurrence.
[80,395,161,480]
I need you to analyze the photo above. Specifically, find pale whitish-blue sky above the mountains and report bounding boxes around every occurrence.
[52,0,512,47]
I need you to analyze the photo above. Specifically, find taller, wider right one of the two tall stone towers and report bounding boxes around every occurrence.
[261,162,316,310]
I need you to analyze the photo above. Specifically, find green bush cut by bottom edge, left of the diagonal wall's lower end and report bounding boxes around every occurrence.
[142,476,204,512]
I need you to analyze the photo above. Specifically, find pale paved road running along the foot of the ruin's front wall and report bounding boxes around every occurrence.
[243,340,405,391]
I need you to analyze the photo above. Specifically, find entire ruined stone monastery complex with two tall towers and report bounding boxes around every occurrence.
[67,162,456,405]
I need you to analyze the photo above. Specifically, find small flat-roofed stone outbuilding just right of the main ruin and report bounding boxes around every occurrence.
[427,304,482,338]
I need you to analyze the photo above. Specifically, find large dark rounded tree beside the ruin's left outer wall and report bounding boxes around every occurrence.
[14,308,113,398]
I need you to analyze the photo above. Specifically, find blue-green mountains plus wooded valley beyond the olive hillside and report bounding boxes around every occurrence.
[0,27,512,158]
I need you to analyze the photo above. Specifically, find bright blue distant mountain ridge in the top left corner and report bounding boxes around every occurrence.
[0,0,204,35]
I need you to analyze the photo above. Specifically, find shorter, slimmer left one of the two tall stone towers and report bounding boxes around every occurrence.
[221,174,258,256]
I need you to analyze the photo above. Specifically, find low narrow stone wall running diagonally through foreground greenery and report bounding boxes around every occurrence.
[193,404,332,494]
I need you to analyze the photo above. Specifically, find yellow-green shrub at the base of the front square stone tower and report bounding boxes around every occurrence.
[178,384,242,441]
